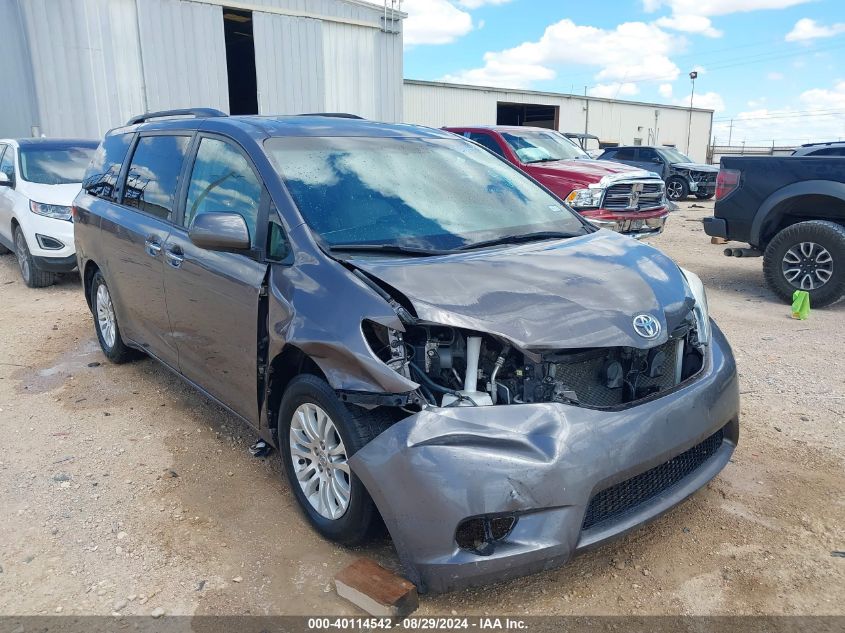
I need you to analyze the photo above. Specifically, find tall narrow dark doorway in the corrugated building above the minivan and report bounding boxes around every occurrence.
[223,7,258,114]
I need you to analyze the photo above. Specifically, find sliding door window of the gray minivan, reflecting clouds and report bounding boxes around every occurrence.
[123,136,191,220]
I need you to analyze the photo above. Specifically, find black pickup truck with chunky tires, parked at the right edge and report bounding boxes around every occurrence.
[704,156,845,307]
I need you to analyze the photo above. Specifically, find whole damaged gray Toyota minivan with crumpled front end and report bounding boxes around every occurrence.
[73,110,739,591]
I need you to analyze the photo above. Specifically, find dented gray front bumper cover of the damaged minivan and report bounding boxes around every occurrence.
[350,325,739,592]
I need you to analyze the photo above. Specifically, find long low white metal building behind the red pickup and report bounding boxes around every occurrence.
[404,79,713,162]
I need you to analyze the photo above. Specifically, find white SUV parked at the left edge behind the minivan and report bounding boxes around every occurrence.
[0,138,97,288]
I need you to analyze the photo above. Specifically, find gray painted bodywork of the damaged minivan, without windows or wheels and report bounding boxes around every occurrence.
[75,117,739,591]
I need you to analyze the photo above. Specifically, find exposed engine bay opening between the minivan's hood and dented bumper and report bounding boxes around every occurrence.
[364,313,704,408]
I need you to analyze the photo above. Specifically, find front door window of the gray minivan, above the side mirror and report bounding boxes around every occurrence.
[183,138,261,246]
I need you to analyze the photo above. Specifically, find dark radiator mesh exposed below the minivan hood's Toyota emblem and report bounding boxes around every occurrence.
[554,339,683,407]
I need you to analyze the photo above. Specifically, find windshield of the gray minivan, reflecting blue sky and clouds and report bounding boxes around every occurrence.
[265,137,587,250]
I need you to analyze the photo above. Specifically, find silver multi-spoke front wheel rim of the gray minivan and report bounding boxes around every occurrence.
[289,402,351,520]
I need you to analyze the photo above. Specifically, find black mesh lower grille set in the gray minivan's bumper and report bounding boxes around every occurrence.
[581,429,724,530]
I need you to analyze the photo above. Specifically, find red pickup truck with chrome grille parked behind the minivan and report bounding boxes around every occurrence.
[444,125,669,237]
